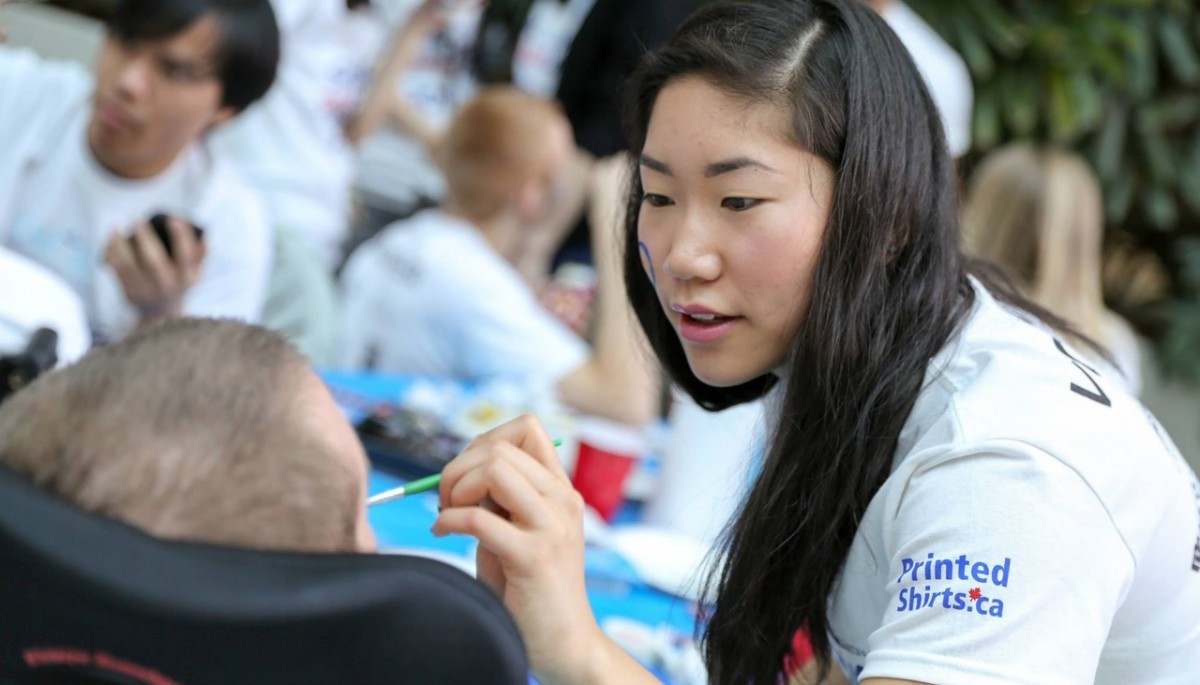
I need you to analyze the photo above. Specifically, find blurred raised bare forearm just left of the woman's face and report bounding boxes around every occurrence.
[558,157,659,423]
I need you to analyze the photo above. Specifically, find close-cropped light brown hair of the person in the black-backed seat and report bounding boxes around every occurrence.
[0,319,362,552]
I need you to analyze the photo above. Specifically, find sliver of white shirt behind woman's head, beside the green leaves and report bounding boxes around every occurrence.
[882,0,974,157]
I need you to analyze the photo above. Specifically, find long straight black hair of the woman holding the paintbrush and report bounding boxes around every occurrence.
[624,0,974,685]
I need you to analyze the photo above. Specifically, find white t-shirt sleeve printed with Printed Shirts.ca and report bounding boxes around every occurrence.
[858,444,1134,685]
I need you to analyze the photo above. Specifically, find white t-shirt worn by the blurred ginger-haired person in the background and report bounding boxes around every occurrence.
[342,210,588,383]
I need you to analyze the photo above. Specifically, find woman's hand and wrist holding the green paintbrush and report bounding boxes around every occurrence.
[433,416,608,683]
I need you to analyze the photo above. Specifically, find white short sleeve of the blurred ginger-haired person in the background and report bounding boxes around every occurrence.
[440,262,588,383]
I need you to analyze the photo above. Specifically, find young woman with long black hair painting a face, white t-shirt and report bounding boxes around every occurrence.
[434,0,1200,685]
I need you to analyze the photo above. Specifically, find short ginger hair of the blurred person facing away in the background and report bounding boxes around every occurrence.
[434,85,566,221]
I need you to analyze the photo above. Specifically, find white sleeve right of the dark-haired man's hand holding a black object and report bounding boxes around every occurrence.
[184,167,274,323]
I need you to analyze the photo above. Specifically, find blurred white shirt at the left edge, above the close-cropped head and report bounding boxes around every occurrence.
[0,247,91,366]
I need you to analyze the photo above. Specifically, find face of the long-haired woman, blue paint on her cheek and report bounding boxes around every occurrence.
[637,77,834,386]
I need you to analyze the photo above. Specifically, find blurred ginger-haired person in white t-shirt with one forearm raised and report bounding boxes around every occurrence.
[341,86,656,422]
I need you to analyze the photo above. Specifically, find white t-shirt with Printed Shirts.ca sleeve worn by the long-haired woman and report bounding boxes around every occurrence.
[829,279,1200,685]
